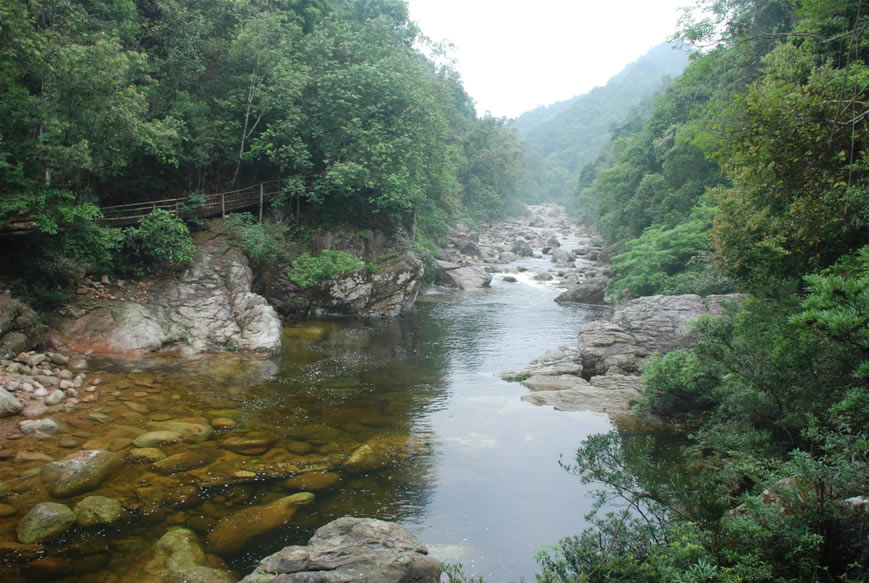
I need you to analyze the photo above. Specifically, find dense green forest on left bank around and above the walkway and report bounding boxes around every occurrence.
[0,0,521,301]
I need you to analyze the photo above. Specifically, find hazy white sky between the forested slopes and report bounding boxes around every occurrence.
[408,0,694,117]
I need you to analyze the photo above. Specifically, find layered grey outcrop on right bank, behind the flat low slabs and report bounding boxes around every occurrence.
[579,294,740,374]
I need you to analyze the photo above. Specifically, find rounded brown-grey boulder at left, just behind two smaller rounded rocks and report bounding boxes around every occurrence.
[39,450,121,498]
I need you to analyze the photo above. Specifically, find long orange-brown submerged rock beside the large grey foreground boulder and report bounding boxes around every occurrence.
[208,492,314,555]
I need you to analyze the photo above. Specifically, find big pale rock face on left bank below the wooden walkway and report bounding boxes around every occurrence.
[56,234,281,353]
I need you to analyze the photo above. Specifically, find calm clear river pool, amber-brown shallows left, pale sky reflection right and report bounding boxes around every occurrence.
[0,238,632,583]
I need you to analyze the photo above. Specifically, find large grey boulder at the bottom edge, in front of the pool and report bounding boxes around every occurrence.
[242,517,441,583]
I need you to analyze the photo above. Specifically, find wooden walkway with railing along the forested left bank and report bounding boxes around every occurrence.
[0,180,282,236]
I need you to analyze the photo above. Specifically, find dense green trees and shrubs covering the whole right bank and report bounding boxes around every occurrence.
[539,0,869,583]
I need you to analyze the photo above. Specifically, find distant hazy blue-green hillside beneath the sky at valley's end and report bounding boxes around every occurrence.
[512,43,688,202]
